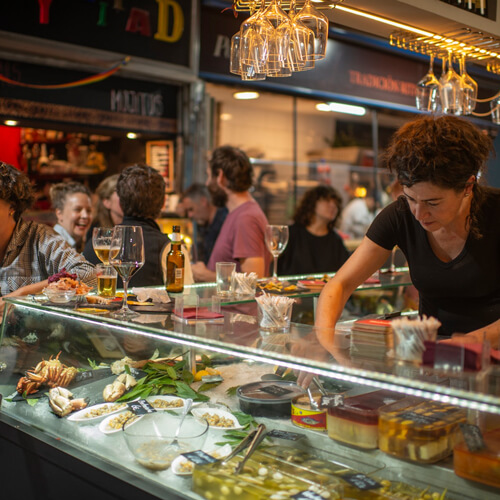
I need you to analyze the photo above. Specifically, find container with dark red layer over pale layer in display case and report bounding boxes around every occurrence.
[327,391,404,449]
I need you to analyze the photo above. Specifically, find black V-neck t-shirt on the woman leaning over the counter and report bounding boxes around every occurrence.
[366,188,500,335]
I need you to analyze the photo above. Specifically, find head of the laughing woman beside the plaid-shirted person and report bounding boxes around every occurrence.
[50,182,92,252]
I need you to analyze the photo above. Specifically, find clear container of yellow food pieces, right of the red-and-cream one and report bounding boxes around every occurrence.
[379,398,466,463]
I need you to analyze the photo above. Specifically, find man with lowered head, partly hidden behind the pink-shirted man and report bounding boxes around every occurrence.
[182,184,227,264]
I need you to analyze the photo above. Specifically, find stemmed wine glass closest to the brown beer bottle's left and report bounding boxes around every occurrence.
[109,226,145,319]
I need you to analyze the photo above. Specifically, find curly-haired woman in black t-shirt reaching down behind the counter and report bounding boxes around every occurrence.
[316,116,500,345]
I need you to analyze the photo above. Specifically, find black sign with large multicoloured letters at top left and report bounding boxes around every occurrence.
[0,0,192,67]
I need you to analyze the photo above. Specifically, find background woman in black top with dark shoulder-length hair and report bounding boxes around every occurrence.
[278,186,349,275]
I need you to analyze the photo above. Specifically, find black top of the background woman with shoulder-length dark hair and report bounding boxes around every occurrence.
[278,224,349,275]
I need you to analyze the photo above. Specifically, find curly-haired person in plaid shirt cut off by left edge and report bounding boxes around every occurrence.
[0,162,96,309]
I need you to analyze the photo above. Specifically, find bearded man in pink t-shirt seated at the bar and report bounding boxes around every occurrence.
[192,146,271,281]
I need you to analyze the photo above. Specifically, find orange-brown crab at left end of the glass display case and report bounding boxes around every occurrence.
[16,351,77,395]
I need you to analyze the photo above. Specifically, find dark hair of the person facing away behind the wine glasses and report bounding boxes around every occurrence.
[116,164,165,219]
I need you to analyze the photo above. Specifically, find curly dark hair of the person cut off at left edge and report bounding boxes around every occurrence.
[0,161,35,222]
